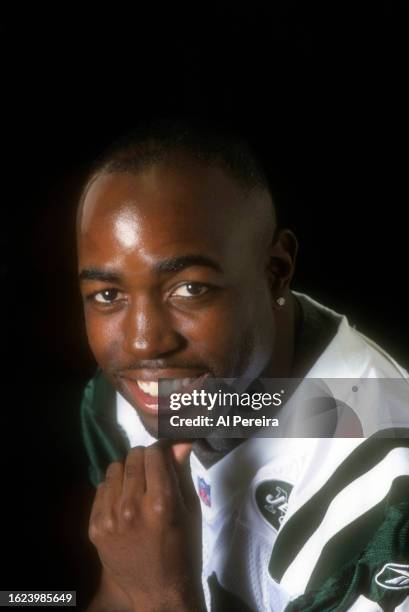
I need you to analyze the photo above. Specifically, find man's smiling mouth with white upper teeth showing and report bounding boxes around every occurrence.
[116,372,210,415]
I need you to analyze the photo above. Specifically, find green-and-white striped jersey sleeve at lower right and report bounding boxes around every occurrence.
[276,437,409,612]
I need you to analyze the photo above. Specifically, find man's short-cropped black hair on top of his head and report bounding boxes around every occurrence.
[81,118,272,206]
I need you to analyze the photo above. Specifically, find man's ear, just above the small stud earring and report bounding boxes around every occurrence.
[267,229,298,301]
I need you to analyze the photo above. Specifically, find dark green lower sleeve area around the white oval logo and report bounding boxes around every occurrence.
[285,476,409,612]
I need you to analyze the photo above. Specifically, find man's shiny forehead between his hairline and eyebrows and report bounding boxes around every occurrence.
[78,161,268,270]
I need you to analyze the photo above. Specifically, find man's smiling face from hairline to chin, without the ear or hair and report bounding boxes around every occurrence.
[78,161,275,431]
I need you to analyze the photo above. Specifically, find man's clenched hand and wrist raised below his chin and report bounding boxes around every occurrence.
[89,442,205,612]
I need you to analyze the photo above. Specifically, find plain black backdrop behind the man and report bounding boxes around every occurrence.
[0,2,409,605]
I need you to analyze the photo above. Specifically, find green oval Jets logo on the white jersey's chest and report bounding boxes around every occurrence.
[256,480,293,531]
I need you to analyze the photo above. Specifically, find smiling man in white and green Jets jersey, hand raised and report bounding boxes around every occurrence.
[77,123,409,612]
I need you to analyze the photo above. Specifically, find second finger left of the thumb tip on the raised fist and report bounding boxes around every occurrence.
[121,446,146,520]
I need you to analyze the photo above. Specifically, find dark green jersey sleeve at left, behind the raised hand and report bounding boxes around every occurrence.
[81,371,129,487]
